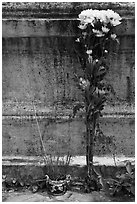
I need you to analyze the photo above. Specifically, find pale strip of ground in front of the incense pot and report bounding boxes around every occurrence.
[2,190,133,202]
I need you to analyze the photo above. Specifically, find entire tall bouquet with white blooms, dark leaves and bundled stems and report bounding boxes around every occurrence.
[74,9,121,176]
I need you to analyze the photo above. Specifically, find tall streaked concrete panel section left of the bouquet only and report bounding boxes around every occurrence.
[3,37,80,106]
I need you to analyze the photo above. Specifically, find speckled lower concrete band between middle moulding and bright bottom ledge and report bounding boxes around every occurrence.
[3,117,135,156]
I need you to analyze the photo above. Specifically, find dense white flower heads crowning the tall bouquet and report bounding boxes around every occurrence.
[78,9,121,37]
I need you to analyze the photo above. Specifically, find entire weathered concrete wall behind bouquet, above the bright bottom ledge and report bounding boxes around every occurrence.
[2,2,135,156]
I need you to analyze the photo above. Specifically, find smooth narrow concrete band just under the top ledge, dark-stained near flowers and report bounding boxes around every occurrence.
[2,18,135,38]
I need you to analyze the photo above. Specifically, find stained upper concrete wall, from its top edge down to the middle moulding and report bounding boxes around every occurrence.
[2,2,135,105]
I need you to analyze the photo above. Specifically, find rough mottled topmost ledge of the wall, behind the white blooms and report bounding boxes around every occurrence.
[2,2,135,18]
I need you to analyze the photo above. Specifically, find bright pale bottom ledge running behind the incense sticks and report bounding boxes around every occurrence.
[2,155,135,166]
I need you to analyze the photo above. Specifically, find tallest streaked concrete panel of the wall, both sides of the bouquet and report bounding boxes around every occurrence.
[2,35,134,106]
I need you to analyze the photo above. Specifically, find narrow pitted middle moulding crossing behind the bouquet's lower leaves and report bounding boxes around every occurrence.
[2,102,135,120]
